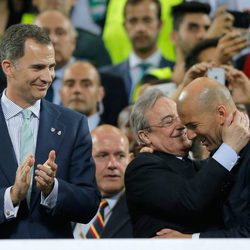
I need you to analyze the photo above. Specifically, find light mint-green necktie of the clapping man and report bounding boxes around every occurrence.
[20,109,35,205]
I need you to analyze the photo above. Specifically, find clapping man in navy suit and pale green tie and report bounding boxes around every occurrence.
[0,24,100,238]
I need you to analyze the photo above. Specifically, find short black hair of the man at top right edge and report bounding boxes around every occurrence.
[171,1,211,30]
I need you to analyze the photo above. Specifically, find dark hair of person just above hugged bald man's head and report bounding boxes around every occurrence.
[185,38,219,70]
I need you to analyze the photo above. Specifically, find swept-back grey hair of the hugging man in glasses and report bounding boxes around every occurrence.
[130,89,165,144]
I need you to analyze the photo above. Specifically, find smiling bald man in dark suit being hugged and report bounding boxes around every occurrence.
[178,77,250,238]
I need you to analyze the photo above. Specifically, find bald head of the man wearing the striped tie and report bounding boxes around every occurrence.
[91,125,130,197]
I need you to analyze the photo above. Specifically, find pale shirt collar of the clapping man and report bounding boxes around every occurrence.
[1,89,41,120]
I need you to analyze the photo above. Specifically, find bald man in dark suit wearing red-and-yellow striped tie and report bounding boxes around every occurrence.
[74,125,132,238]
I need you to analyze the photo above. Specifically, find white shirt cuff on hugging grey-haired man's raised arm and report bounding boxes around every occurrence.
[212,143,239,171]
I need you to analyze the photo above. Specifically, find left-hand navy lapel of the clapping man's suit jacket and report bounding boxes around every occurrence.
[0,101,18,185]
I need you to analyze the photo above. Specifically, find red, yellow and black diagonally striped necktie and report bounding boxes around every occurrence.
[86,199,108,239]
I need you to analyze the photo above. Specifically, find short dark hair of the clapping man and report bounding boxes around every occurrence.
[0,24,52,62]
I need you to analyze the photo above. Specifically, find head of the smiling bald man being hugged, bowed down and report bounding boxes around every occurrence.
[177,77,236,152]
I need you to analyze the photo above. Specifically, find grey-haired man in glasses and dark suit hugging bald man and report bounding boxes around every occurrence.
[125,90,249,237]
